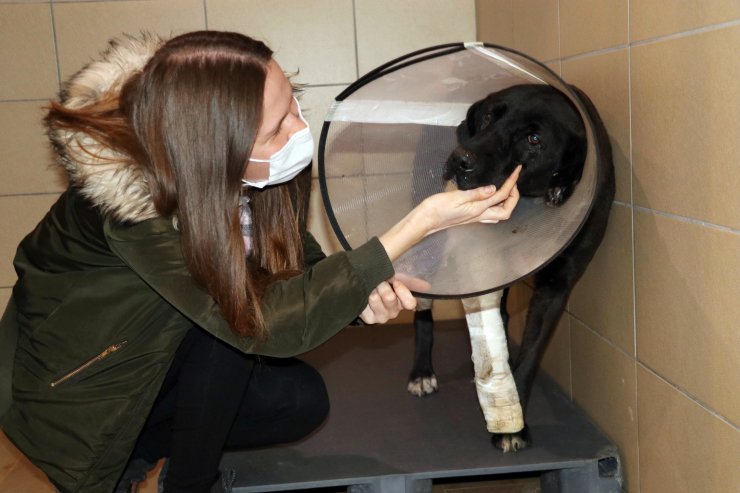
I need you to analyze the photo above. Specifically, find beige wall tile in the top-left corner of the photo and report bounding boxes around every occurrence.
[0,4,59,100]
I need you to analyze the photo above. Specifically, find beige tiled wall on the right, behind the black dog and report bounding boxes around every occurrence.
[476,0,740,493]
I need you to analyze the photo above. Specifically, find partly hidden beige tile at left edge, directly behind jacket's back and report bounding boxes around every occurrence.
[0,194,58,287]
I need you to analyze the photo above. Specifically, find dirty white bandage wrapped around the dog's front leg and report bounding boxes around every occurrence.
[463,291,524,433]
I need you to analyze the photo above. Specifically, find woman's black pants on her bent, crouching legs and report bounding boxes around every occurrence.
[132,327,329,493]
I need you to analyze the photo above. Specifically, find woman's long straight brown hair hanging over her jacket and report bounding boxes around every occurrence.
[47,31,310,339]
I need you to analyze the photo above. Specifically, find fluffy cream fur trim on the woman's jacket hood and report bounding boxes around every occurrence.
[47,33,164,222]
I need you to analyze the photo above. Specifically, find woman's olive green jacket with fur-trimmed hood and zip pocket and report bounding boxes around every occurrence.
[0,36,393,492]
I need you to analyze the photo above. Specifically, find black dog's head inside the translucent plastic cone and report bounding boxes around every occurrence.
[444,84,586,207]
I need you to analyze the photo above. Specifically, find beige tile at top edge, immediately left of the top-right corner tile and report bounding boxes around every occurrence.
[559,0,628,57]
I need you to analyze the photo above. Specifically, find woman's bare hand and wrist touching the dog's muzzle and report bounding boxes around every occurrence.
[379,166,521,260]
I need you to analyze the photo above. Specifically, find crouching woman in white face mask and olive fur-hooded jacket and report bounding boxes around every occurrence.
[2,31,518,492]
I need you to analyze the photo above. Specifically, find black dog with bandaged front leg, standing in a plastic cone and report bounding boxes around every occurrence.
[409,85,615,451]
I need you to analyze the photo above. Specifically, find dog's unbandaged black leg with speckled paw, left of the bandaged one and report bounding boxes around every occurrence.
[407,298,437,397]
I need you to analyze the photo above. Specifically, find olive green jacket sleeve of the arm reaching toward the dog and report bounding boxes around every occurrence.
[105,219,394,357]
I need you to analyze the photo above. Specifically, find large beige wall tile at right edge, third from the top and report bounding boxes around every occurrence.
[635,210,740,423]
